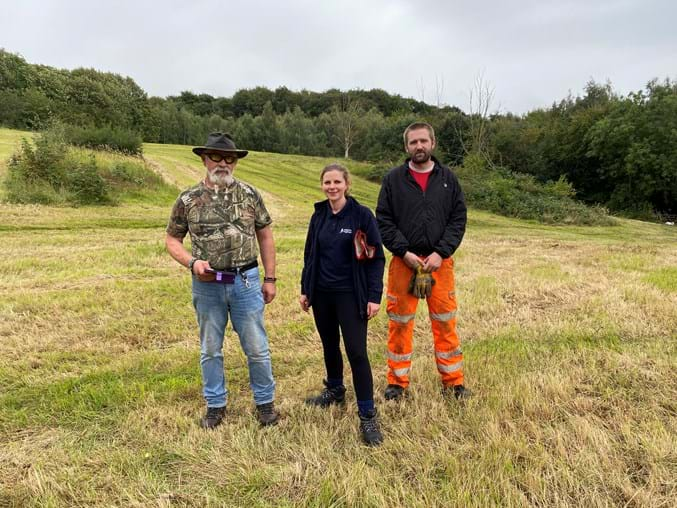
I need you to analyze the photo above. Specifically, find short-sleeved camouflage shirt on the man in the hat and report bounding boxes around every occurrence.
[167,180,272,270]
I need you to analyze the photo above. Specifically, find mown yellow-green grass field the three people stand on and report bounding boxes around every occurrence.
[0,130,677,507]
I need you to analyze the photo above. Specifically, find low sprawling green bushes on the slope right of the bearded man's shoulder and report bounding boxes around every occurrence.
[456,155,614,225]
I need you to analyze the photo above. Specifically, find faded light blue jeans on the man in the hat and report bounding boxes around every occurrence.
[193,268,275,407]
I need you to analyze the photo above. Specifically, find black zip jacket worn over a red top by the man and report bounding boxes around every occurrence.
[376,157,467,258]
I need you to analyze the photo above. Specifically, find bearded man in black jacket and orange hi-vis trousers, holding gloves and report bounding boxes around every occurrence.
[376,123,470,400]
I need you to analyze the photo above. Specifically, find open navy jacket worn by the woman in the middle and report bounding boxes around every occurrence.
[301,197,385,318]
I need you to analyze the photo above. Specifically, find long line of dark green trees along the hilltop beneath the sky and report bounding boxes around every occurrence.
[0,49,677,215]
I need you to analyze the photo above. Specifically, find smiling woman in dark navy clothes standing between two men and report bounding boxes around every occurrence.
[299,164,385,445]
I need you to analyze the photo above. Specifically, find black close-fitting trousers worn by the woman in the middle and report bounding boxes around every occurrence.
[312,290,374,400]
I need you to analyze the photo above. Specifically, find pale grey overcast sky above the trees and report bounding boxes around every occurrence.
[0,0,677,113]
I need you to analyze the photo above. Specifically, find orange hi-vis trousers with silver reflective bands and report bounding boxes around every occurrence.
[387,257,463,388]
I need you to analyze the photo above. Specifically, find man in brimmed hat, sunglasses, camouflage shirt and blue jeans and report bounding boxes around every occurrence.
[165,132,279,429]
